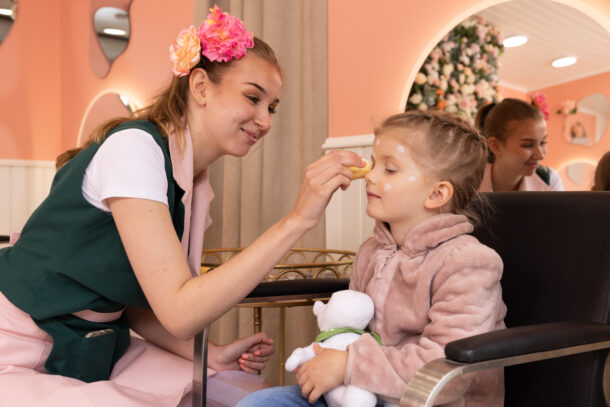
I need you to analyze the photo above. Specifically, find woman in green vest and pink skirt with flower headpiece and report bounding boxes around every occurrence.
[0,7,361,407]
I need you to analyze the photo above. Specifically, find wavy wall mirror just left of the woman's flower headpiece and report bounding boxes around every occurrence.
[91,3,130,77]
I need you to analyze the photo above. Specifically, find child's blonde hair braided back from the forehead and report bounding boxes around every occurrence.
[375,110,487,222]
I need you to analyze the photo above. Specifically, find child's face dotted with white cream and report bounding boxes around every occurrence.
[365,128,434,239]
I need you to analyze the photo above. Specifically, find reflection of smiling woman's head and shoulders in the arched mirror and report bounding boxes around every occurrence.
[475,98,563,192]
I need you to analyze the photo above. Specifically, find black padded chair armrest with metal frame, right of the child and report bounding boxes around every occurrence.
[445,322,610,363]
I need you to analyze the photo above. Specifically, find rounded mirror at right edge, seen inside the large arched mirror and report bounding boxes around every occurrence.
[564,93,610,146]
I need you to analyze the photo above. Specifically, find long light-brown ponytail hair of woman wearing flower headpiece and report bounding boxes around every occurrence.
[55,37,281,169]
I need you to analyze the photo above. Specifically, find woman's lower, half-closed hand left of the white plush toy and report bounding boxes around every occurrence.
[209,332,275,373]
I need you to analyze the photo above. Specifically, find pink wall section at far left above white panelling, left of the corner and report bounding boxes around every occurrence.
[0,0,61,159]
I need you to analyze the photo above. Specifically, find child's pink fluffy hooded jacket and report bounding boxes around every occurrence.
[345,214,506,407]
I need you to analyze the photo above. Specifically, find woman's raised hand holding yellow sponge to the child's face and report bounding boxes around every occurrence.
[289,150,364,233]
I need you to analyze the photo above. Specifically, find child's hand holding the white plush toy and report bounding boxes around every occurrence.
[296,344,348,403]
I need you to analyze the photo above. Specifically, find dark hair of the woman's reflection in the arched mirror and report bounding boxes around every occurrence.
[475,98,544,162]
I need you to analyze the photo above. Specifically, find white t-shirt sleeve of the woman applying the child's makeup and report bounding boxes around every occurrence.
[82,129,167,212]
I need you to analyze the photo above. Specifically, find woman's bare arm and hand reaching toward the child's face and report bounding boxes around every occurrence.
[108,151,362,339]
